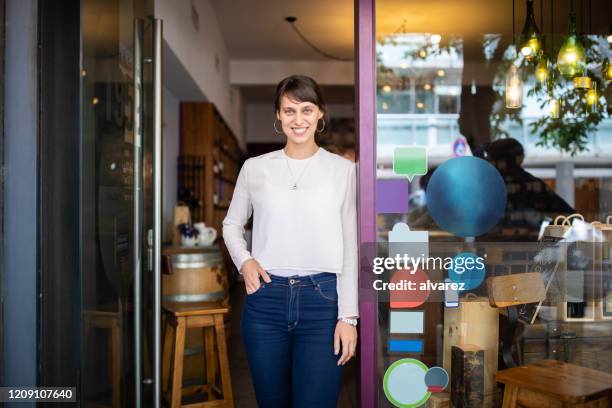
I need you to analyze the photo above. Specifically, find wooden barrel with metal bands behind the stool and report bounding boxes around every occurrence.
[162,245,231,383]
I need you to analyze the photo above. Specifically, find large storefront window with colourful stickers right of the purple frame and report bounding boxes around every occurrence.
[373,0,612,407]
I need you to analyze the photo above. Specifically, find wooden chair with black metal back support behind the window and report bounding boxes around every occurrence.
[487,272,612,408]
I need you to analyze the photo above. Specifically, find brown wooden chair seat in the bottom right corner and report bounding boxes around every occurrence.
[495,360,612,408]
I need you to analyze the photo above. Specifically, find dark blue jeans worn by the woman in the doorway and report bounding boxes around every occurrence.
[240,273,342,408]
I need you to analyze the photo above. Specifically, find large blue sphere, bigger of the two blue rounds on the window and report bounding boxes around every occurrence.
[426,156,506,237]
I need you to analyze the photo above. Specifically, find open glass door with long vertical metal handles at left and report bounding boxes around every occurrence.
[80,0,161,407]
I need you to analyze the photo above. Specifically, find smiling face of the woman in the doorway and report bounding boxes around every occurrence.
[276,95,323,144]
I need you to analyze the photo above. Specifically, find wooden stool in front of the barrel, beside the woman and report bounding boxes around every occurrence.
[163,302,234,408]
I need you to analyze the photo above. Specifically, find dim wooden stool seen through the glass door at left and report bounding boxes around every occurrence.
[83,310,121,408]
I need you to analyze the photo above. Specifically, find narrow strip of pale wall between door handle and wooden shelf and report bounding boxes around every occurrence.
[162,87,180,240]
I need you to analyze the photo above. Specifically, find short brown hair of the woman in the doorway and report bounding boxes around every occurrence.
[274,75,329,142]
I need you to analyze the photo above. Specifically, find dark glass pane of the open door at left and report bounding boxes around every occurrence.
[81,0,152,406]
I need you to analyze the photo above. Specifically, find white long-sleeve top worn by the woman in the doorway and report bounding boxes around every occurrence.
[223,148,359,317]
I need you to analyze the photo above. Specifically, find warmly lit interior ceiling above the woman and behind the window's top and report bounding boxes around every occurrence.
[212,0,612,60]
